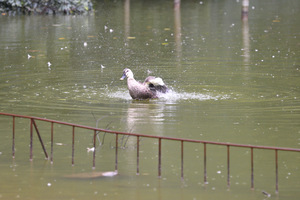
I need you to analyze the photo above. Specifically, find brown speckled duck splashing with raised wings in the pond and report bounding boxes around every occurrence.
[120,68,169,100]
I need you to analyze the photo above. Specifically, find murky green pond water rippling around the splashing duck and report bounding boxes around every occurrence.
[0,0,300,199]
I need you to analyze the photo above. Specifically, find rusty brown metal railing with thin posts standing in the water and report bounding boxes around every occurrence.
[0,112,300,193]
